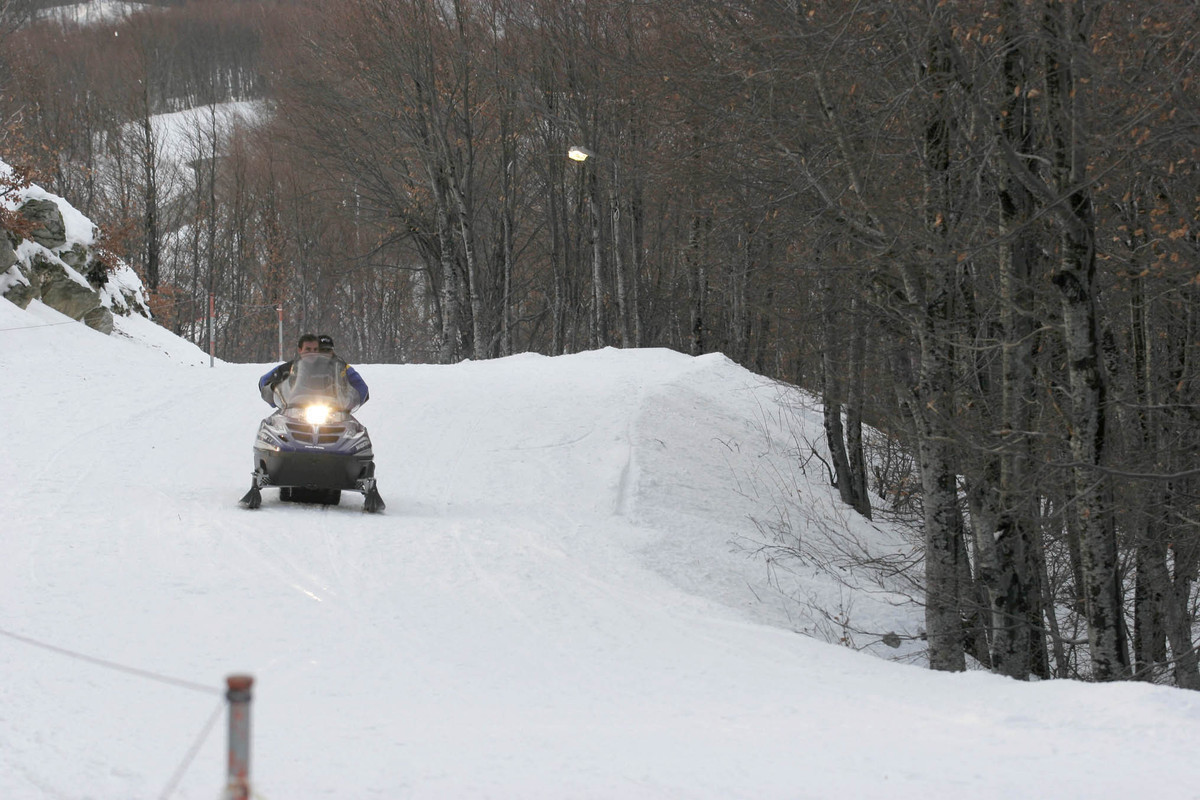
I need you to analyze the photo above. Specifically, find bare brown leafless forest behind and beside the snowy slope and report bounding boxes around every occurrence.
[0,0,1200,688]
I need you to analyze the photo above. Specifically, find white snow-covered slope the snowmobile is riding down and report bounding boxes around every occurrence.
[0,300,1200,800]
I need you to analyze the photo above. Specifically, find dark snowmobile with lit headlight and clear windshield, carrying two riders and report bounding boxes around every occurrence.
[240,353,385,513]
